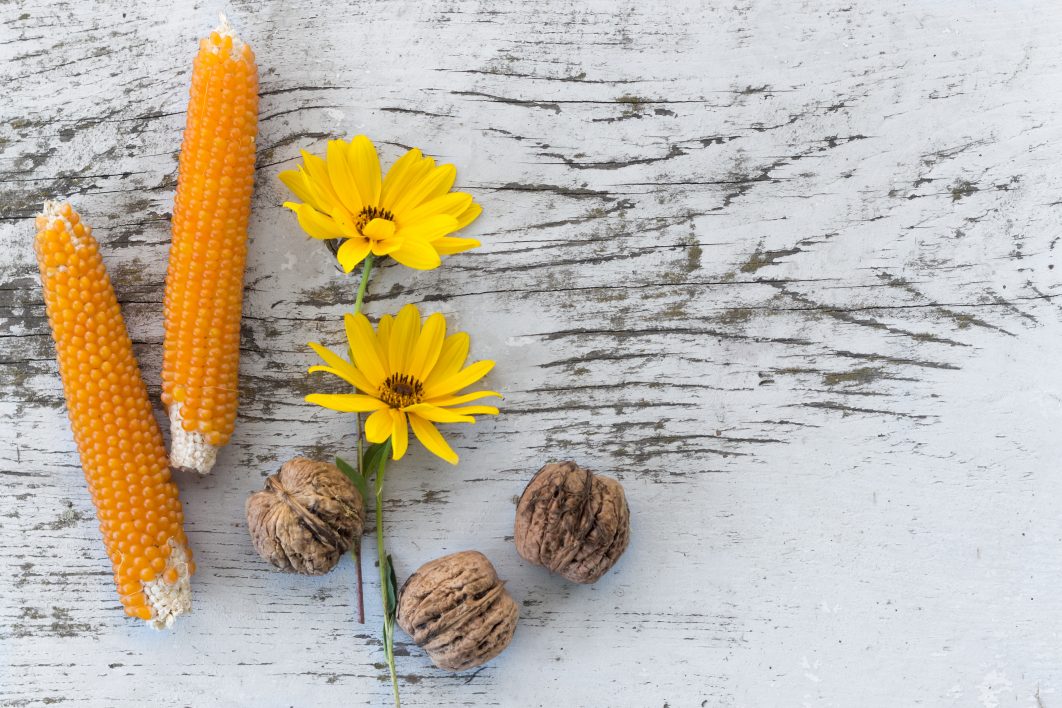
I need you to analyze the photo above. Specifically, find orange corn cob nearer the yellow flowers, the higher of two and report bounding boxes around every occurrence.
[162,17,258,474]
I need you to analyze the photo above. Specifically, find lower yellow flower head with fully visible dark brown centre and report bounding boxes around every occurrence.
[306,305,500,465]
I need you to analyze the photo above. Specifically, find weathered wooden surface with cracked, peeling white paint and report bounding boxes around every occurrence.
[0,0,1062,708]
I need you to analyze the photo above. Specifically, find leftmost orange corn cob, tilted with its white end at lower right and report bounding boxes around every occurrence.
[34,202,195,628]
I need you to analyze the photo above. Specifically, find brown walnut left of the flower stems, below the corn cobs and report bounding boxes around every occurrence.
[246,457,364,575]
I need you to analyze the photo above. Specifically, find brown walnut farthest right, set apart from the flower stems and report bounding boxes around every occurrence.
[514,462,631,583]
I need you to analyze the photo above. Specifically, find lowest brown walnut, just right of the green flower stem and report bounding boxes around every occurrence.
[398,551,519,671]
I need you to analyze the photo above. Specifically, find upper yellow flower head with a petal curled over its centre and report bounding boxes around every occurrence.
[279,135,483,273]
